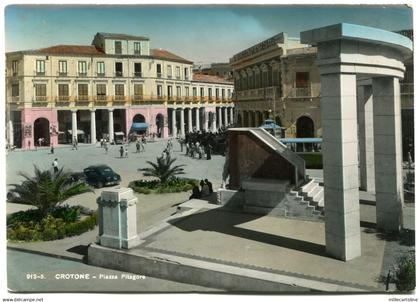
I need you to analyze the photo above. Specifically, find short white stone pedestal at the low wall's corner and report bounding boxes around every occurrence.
[97,188,140,249]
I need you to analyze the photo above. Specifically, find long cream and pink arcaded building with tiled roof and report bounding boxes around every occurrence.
[6,33,233,148]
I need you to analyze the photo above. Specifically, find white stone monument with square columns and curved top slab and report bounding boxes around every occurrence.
[301,23,412,260]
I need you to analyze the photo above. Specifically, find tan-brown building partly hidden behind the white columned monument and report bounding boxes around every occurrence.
[230,30,414,158]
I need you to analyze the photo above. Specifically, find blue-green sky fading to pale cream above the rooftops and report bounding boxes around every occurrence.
[5,5,413,64]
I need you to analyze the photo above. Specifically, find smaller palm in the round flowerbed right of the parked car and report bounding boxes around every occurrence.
[141,156,185,184]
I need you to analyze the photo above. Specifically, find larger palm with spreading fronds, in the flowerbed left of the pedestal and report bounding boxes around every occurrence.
[10,166,92,217]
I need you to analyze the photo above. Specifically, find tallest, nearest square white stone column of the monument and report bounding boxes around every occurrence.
[321,73,361,261]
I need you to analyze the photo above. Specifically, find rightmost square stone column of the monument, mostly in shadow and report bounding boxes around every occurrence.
[372,77,404,231]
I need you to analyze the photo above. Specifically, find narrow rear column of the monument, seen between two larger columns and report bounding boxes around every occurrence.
[357,85,375,192]
